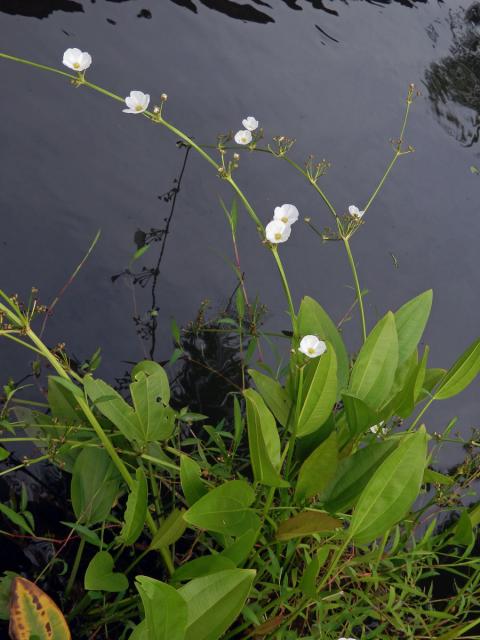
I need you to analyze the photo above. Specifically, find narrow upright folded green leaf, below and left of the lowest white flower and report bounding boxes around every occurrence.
[244,389,285,487]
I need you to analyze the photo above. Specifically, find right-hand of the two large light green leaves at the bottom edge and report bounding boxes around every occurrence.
[178,569,255,640]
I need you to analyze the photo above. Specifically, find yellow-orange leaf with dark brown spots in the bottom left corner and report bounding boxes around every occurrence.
[9,576,72,640]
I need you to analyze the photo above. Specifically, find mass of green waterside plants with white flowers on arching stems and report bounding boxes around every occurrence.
[0,47,480,640]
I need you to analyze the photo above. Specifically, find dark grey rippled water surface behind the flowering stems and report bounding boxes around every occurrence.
[0,0,480,470]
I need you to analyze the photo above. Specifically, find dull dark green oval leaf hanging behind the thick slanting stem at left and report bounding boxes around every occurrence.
[70,448,120,525]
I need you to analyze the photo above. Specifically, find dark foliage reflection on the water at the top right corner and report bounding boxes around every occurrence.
[425,2,480,147]
